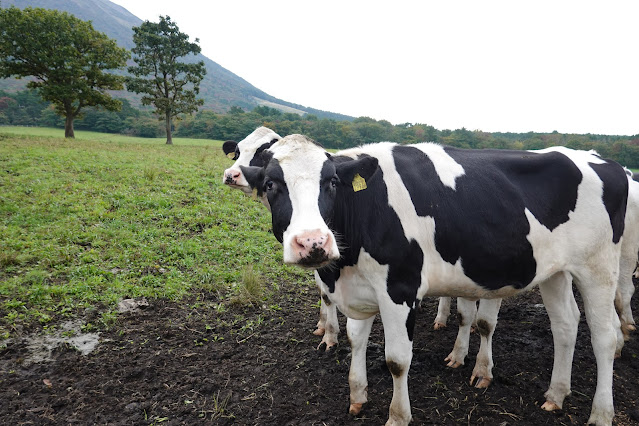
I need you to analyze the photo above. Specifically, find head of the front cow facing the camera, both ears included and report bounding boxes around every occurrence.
[241,135,377,269]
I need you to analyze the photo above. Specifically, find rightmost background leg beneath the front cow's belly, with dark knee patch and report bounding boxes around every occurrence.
[470,299,501,388]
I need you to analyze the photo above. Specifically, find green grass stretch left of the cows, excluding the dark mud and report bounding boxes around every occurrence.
[0,127,311,340]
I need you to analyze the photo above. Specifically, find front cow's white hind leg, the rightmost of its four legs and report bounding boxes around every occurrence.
[575,268,619,425]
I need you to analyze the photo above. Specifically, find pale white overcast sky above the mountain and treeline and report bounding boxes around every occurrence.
[107,0,639,135]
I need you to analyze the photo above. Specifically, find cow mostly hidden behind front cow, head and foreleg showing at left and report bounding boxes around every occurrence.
[222,126,339,351]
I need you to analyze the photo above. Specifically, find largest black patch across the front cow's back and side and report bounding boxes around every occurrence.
[393,145,582,290]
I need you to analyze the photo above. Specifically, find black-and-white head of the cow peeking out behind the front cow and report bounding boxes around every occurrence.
[222,127,281,194]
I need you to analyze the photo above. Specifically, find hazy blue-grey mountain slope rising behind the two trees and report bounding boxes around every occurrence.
[0,0,353,120]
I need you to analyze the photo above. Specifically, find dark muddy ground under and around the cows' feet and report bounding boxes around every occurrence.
[0,283,639,425]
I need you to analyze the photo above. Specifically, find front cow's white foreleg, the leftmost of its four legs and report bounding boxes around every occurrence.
[346,315,375,415]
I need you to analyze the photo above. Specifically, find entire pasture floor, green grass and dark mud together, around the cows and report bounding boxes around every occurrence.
[0,128,639,425]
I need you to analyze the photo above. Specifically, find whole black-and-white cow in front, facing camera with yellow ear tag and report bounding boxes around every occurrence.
[240,135,628,425]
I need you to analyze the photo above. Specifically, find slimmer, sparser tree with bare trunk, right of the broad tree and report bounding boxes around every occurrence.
[126,16,206,144]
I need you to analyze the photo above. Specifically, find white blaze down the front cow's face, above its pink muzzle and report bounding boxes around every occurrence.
[271,135,340,263]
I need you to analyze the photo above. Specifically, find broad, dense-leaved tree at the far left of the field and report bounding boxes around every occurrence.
[0,7,129,138]
